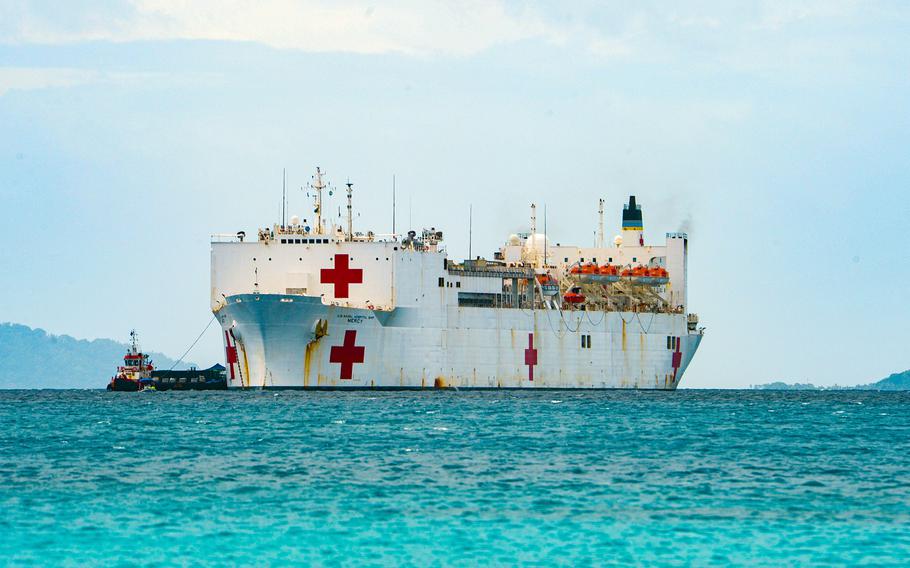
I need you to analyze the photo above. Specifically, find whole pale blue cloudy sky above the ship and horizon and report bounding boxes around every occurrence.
[0,0,910,387]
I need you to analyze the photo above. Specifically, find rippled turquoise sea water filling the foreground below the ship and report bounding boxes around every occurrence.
[0,391,910,566]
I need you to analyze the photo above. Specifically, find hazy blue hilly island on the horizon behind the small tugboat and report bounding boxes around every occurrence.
[0,323,192,389]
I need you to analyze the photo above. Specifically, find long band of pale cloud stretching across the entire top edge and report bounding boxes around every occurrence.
[0,0,896,71]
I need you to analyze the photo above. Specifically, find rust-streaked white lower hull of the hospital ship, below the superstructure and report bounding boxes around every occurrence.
[218,294,702,390]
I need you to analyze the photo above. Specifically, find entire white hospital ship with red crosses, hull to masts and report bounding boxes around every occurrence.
[211,169,703,389]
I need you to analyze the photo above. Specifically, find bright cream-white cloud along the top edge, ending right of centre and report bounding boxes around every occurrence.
[3,0,564,55]
